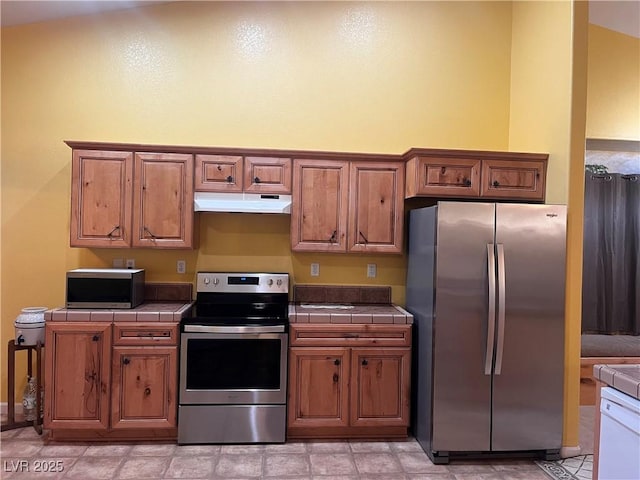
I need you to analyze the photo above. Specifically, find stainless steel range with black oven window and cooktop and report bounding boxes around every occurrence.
[178,272,289,444]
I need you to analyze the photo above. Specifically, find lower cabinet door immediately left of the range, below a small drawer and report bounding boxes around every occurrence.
[111,347,178,429]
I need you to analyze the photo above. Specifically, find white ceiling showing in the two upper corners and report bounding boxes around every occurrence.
[0,0,640,38]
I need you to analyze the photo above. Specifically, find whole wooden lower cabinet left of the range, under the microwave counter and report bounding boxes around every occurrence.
[44,322,178,440]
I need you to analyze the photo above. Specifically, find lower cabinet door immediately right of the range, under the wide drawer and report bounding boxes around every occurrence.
[287,347,349,427]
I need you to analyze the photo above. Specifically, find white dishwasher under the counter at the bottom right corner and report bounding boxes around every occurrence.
[598,387,640,480]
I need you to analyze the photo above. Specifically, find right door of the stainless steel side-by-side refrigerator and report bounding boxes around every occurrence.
[491,204,566,451]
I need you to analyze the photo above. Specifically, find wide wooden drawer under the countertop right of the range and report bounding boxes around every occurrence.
[289,324,411,347]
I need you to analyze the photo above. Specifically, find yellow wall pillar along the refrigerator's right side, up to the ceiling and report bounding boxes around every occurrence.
[509,2,587,454]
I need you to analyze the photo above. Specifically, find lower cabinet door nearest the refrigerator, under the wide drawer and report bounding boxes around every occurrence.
[350,348,411,427]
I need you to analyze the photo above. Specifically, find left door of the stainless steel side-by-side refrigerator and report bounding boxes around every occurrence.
[431,202,495,451]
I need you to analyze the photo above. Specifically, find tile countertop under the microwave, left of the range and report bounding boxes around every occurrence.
[44,302,193,322]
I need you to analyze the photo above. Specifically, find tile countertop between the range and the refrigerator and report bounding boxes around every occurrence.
[289,303,413,324]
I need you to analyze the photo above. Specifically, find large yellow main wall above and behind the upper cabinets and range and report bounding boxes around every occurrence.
[0,1,588,450]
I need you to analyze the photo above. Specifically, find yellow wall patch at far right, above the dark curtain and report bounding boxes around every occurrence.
[587,25,640,140]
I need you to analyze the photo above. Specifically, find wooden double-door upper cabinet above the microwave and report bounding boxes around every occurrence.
[70,149,194,248]
